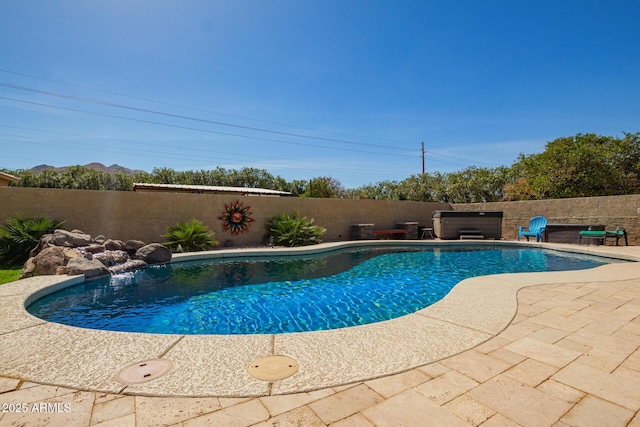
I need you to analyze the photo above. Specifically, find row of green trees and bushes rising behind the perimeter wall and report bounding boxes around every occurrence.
[3,133,640,203]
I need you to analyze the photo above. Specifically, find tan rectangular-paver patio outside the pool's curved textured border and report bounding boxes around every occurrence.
[0,242,640,427]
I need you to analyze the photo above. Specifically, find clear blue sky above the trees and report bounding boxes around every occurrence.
[0,0,640,188]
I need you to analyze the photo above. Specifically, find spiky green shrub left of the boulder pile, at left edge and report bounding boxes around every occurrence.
[0,213,64,265]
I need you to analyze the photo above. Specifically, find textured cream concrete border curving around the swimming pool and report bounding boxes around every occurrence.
[0,240,640,397]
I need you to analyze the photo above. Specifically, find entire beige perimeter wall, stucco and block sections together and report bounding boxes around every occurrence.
[0,187,640,246]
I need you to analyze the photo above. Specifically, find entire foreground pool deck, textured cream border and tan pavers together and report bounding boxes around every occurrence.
[0,244,640,426]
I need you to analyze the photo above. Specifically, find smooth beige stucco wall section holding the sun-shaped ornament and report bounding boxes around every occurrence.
[0,187,451,246]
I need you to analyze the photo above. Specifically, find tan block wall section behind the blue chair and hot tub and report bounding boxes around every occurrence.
[453,194,640,245]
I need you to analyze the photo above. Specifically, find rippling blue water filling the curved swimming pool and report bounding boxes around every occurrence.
[27,247,615,334]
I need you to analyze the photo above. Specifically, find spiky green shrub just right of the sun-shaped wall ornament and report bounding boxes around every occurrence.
[264,211,327,247]
